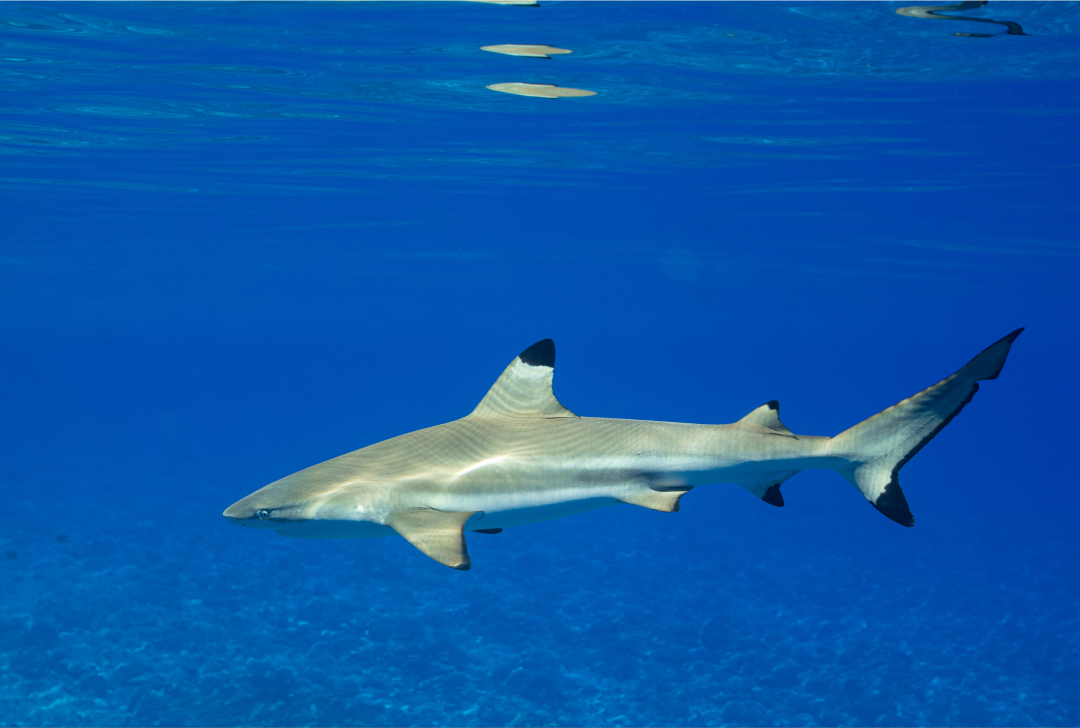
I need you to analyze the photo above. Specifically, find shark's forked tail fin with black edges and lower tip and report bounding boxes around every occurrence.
[829,328,1024,526]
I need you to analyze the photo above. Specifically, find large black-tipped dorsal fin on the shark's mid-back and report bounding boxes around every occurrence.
[470,339,577,418]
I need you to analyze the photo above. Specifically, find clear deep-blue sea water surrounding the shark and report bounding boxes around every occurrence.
[0,0,1080,726]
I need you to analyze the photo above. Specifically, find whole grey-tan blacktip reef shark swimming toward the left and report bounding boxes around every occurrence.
[225,328,1024,569]
